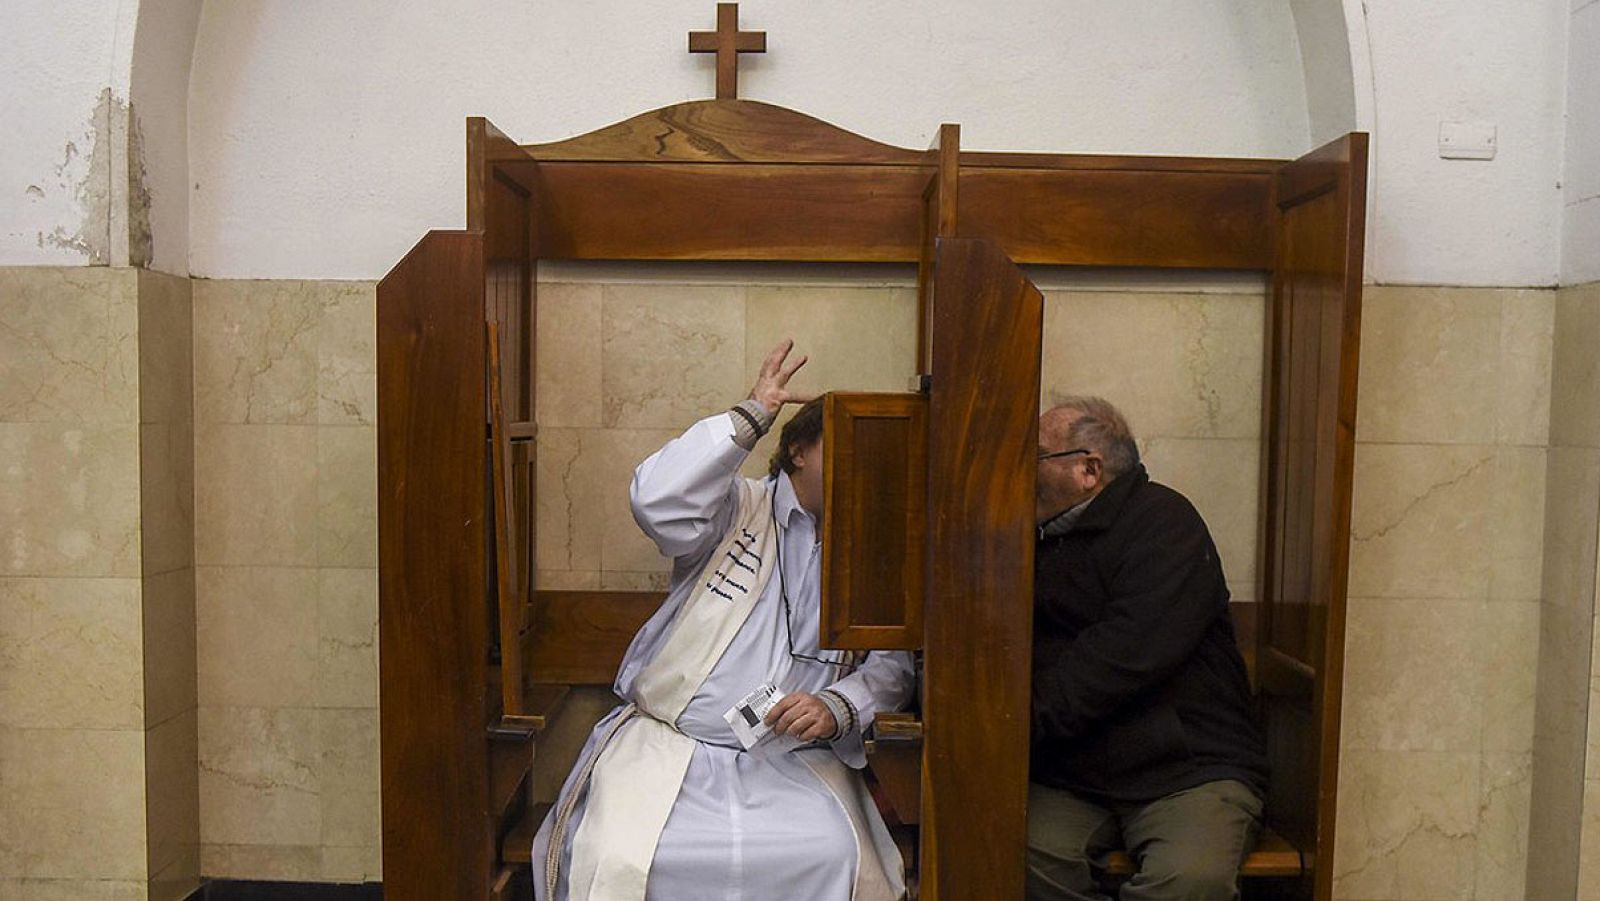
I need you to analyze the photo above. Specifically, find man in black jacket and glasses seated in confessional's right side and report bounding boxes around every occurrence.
[1027,397,1267,901]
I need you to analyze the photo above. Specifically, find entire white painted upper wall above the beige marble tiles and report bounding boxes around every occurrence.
[0,0,1600,285]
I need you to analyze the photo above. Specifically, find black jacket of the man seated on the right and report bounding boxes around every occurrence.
[1032,466,1267,803]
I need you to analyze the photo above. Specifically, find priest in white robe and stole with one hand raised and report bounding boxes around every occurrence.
[533,341,914,901]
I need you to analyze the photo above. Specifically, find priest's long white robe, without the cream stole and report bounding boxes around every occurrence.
[533,413,914,901]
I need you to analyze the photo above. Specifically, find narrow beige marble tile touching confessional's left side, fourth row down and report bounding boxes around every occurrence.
[317,709,382,847]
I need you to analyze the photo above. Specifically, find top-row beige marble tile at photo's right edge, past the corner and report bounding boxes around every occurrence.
[1550,283,1600,448]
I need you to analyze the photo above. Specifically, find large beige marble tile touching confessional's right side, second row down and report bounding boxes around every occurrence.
[1349,443,1501,599]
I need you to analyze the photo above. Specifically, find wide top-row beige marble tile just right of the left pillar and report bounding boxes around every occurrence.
[194,280,322,424]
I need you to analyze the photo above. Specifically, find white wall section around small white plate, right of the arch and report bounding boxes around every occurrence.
[1365,0,1571,286]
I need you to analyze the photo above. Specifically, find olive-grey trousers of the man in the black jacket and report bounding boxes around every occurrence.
[1027,779,1261,901]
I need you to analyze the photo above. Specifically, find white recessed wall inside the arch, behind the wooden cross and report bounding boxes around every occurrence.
[189,0,1309,278]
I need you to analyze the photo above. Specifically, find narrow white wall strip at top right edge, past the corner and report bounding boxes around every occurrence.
[1562,0,1600,285]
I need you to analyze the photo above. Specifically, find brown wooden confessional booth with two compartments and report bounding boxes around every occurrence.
[378,24,1366,901]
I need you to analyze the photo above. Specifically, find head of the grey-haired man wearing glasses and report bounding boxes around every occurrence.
[1034,395,1139,523]
